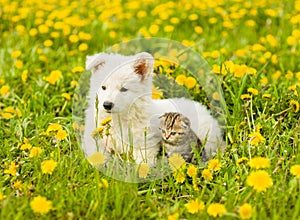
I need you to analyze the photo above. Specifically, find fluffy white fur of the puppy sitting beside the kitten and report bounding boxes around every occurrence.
[83,52,225,164]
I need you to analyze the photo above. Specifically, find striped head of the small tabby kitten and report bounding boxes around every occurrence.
[159,112,191,144]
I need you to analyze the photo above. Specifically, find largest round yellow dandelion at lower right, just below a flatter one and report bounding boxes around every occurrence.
[247,170,273,192]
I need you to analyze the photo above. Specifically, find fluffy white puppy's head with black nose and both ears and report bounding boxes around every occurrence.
[87,52,154,113]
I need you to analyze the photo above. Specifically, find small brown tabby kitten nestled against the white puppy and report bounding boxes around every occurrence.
[159,112,207,163]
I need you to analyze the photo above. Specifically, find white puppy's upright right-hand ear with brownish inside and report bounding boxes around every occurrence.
[133,52,154,81]
